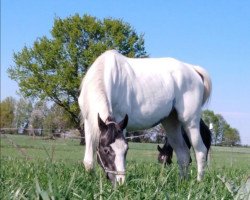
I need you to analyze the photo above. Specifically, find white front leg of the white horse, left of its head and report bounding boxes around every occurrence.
[83,120,95,171]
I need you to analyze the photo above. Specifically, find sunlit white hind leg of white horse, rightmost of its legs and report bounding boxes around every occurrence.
[184,119,207,181]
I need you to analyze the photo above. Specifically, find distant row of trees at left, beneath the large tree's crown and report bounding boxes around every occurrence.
[0,97,79,135]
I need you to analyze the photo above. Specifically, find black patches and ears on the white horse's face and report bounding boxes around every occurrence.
[97,114,128,184]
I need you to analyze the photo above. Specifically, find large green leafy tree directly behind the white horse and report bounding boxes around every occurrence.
[8,14,147,143]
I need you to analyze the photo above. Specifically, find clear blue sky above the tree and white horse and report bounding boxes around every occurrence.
[1,0,250,144]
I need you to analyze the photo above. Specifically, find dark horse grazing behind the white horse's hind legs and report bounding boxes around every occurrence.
[157,119,211,165]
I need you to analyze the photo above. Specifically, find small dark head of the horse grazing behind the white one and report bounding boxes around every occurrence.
[157,141,173,165]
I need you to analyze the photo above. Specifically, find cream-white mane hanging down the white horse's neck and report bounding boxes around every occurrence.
[78,52,116,144]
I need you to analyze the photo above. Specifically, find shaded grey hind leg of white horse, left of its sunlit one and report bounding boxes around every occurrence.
[162,110,190,178]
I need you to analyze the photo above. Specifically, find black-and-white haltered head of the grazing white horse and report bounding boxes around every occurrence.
[97,114,128,184]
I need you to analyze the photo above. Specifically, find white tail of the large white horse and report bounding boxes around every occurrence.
[193,66,212,105]
